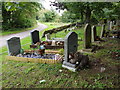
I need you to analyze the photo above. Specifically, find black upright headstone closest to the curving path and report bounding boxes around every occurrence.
[31,30,40,44]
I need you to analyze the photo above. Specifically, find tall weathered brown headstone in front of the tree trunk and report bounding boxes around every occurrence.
[84,24,91,49]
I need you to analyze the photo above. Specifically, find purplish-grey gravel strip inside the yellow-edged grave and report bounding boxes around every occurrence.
[17,54,56,60]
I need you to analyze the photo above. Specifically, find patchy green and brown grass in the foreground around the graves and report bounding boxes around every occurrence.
[2,25,120,88]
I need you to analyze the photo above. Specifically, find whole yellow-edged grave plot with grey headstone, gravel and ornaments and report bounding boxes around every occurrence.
[6,37,63,63]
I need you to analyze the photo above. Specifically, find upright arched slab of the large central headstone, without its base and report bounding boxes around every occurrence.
[64,32,78,62]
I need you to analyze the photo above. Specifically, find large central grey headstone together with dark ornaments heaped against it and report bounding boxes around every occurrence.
[62,32,89,72]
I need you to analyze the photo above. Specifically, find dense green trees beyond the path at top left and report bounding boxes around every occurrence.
[2,2,42,30]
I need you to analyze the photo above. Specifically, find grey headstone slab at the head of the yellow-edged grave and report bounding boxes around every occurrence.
[7,37,21,55]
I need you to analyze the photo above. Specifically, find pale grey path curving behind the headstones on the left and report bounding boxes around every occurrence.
[0,23,47,47]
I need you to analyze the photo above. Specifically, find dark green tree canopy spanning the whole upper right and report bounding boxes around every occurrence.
[51,2,120,23]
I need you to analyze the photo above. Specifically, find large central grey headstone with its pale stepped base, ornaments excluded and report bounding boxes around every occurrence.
[62,32,78,71]
